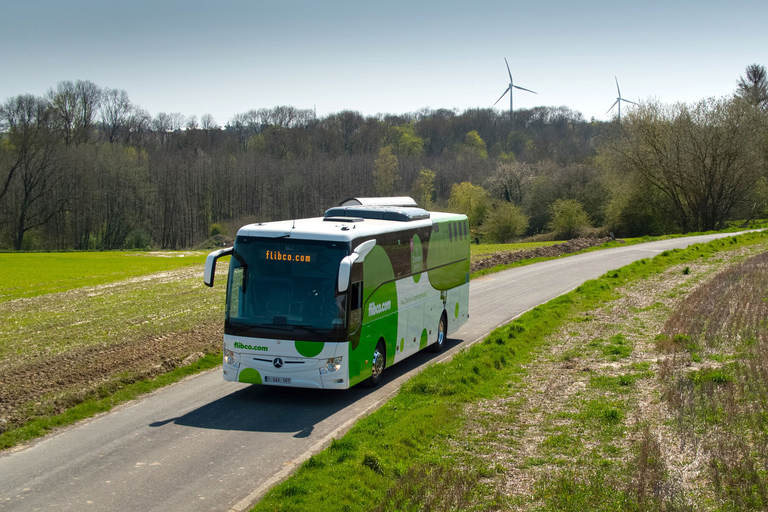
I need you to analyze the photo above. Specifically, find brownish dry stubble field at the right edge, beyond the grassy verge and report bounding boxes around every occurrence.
[663,253,768,510]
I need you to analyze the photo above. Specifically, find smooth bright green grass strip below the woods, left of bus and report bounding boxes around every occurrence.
[0,251,206,302]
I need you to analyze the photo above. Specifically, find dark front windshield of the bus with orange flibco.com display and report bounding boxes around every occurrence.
[224,236,349,341]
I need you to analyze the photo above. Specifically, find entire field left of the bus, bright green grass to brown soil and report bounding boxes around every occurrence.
[0,251,227,449]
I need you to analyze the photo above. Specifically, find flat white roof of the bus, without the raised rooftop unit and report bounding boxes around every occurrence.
[237,209,466,246]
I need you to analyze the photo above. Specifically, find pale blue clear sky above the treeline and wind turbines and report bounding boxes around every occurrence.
[0,0,768,126]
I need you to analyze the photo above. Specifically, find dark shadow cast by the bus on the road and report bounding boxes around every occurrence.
[149,339,462,438]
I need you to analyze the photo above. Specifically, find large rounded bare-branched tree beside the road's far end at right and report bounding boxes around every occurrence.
[600,98,766,232]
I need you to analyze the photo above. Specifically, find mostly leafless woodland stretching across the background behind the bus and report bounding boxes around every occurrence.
[0,64,768,251]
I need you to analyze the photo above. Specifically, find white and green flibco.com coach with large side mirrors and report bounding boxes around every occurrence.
[205,198,470,389]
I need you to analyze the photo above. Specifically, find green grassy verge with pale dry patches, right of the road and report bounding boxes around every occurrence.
[254,233,768,511]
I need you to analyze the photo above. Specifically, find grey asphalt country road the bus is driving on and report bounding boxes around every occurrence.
[0,235,748,511]
